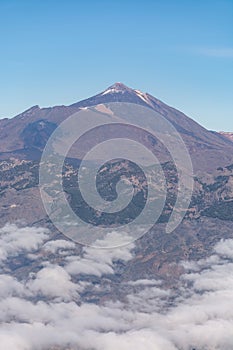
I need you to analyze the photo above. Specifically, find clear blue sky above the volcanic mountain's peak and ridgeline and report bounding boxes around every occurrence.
[0,0,233,131]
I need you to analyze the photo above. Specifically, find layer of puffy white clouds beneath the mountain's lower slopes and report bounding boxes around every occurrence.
[0,225,233,350]
